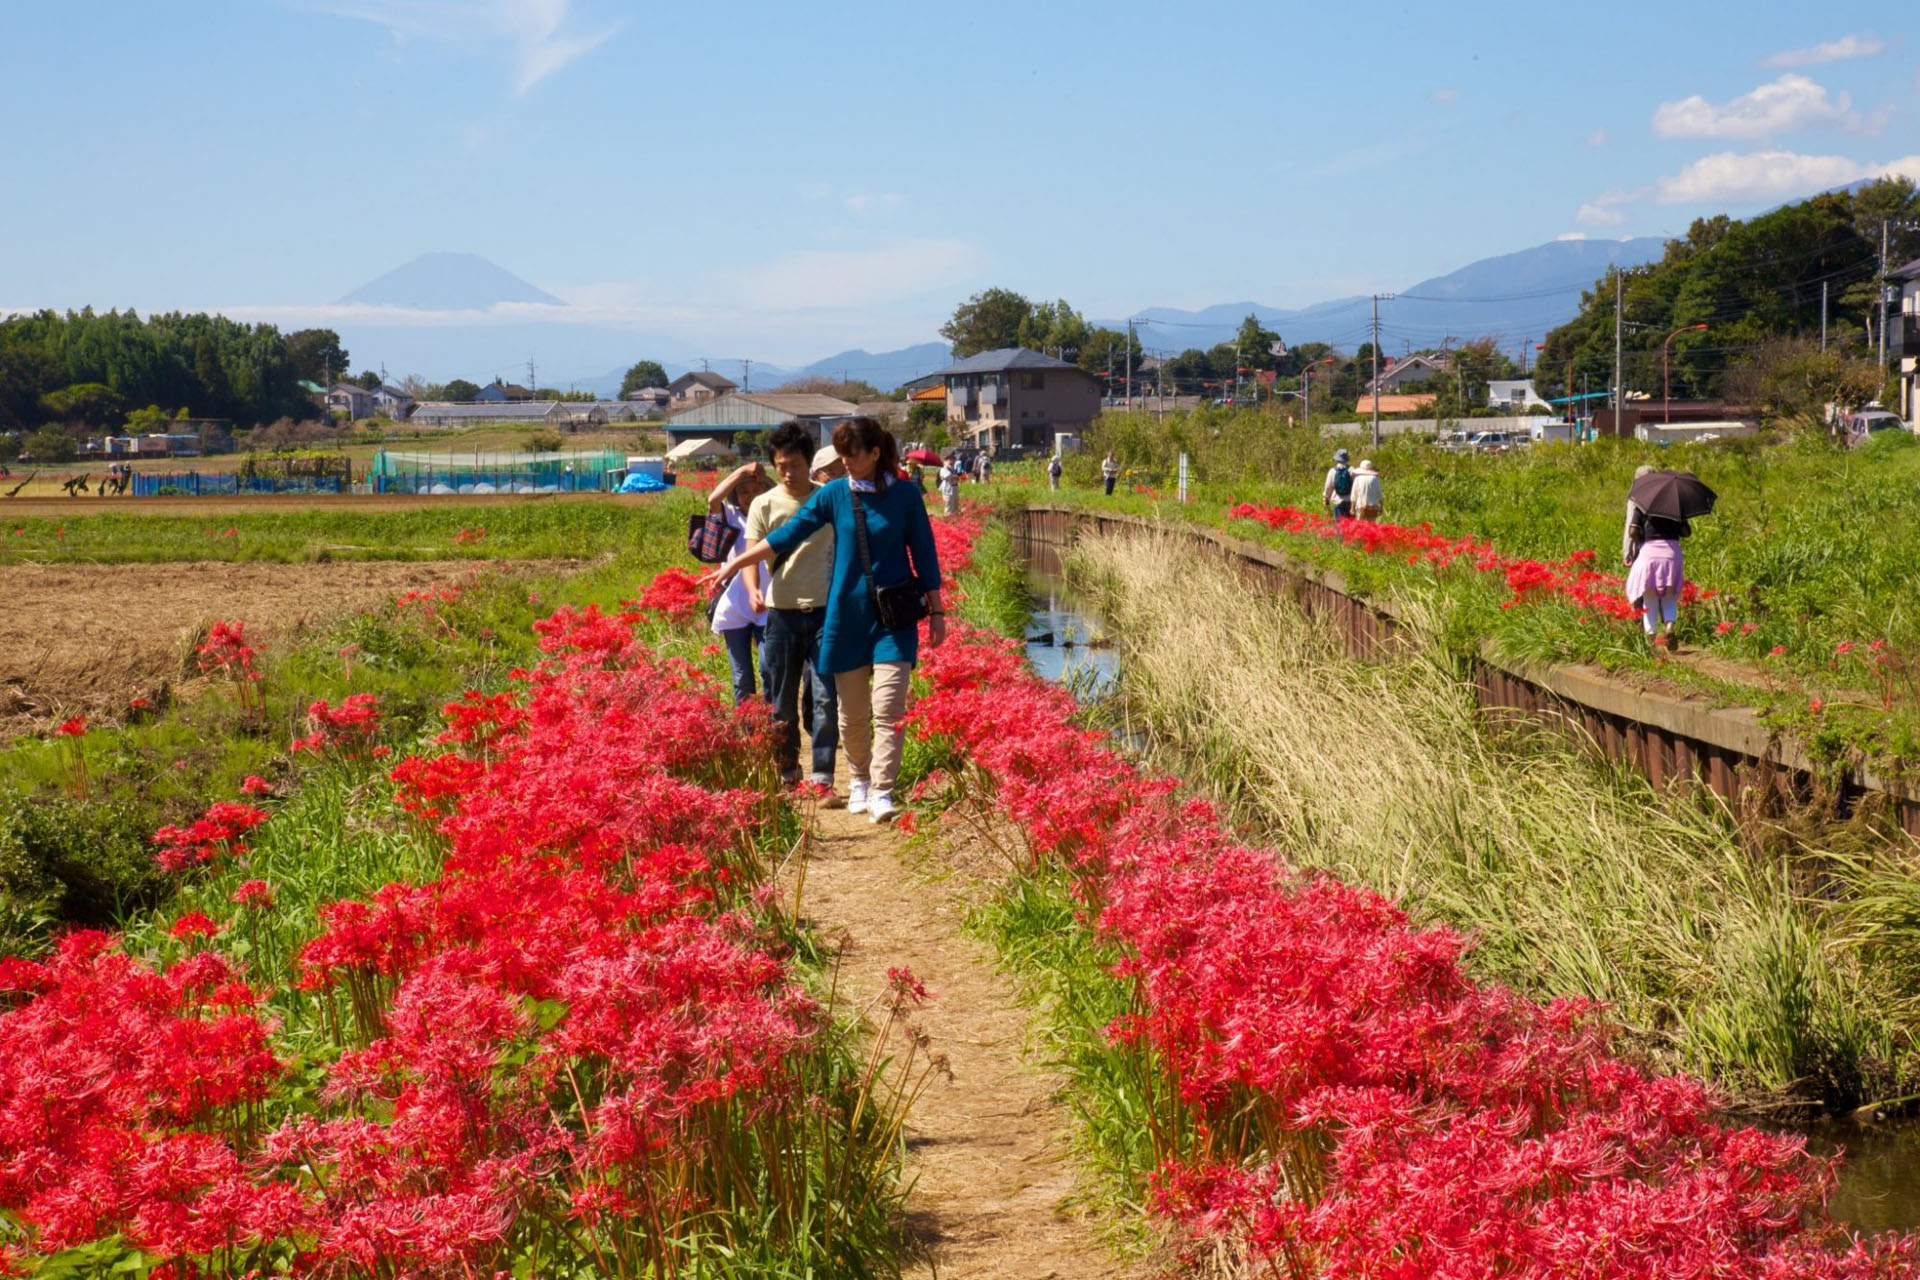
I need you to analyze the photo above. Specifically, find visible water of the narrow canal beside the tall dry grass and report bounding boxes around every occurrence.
[1016,543,1920,1232]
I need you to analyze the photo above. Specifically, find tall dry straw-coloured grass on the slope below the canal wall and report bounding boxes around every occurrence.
[1068,533,1920,1103]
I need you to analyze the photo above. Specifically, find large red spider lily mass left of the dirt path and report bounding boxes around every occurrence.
[0,594,867,1278]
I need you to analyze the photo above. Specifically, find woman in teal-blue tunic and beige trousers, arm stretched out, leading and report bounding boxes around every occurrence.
[705,418,947,823]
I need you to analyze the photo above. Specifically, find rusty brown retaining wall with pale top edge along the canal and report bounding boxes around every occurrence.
[1012,503,1920,837]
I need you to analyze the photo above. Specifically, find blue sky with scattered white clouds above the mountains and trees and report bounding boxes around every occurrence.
[0,0,1920,363]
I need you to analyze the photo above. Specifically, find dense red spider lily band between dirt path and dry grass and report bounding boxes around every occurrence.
[912,617,1920,1280]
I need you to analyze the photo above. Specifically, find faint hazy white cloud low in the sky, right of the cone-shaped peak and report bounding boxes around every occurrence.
[720,240,985,311]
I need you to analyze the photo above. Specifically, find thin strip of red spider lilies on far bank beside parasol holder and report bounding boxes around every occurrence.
[1227,503,1715,622]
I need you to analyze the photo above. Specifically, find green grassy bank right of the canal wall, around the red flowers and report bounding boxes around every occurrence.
[996,413,1920,764]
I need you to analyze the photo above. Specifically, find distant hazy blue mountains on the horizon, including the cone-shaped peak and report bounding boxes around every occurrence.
[338,236,1665,395]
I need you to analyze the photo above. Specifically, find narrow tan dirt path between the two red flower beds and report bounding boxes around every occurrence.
[803,810,1150,1280]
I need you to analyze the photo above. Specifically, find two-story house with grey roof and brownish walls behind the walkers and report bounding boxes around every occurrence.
[935,347,1100,449]
